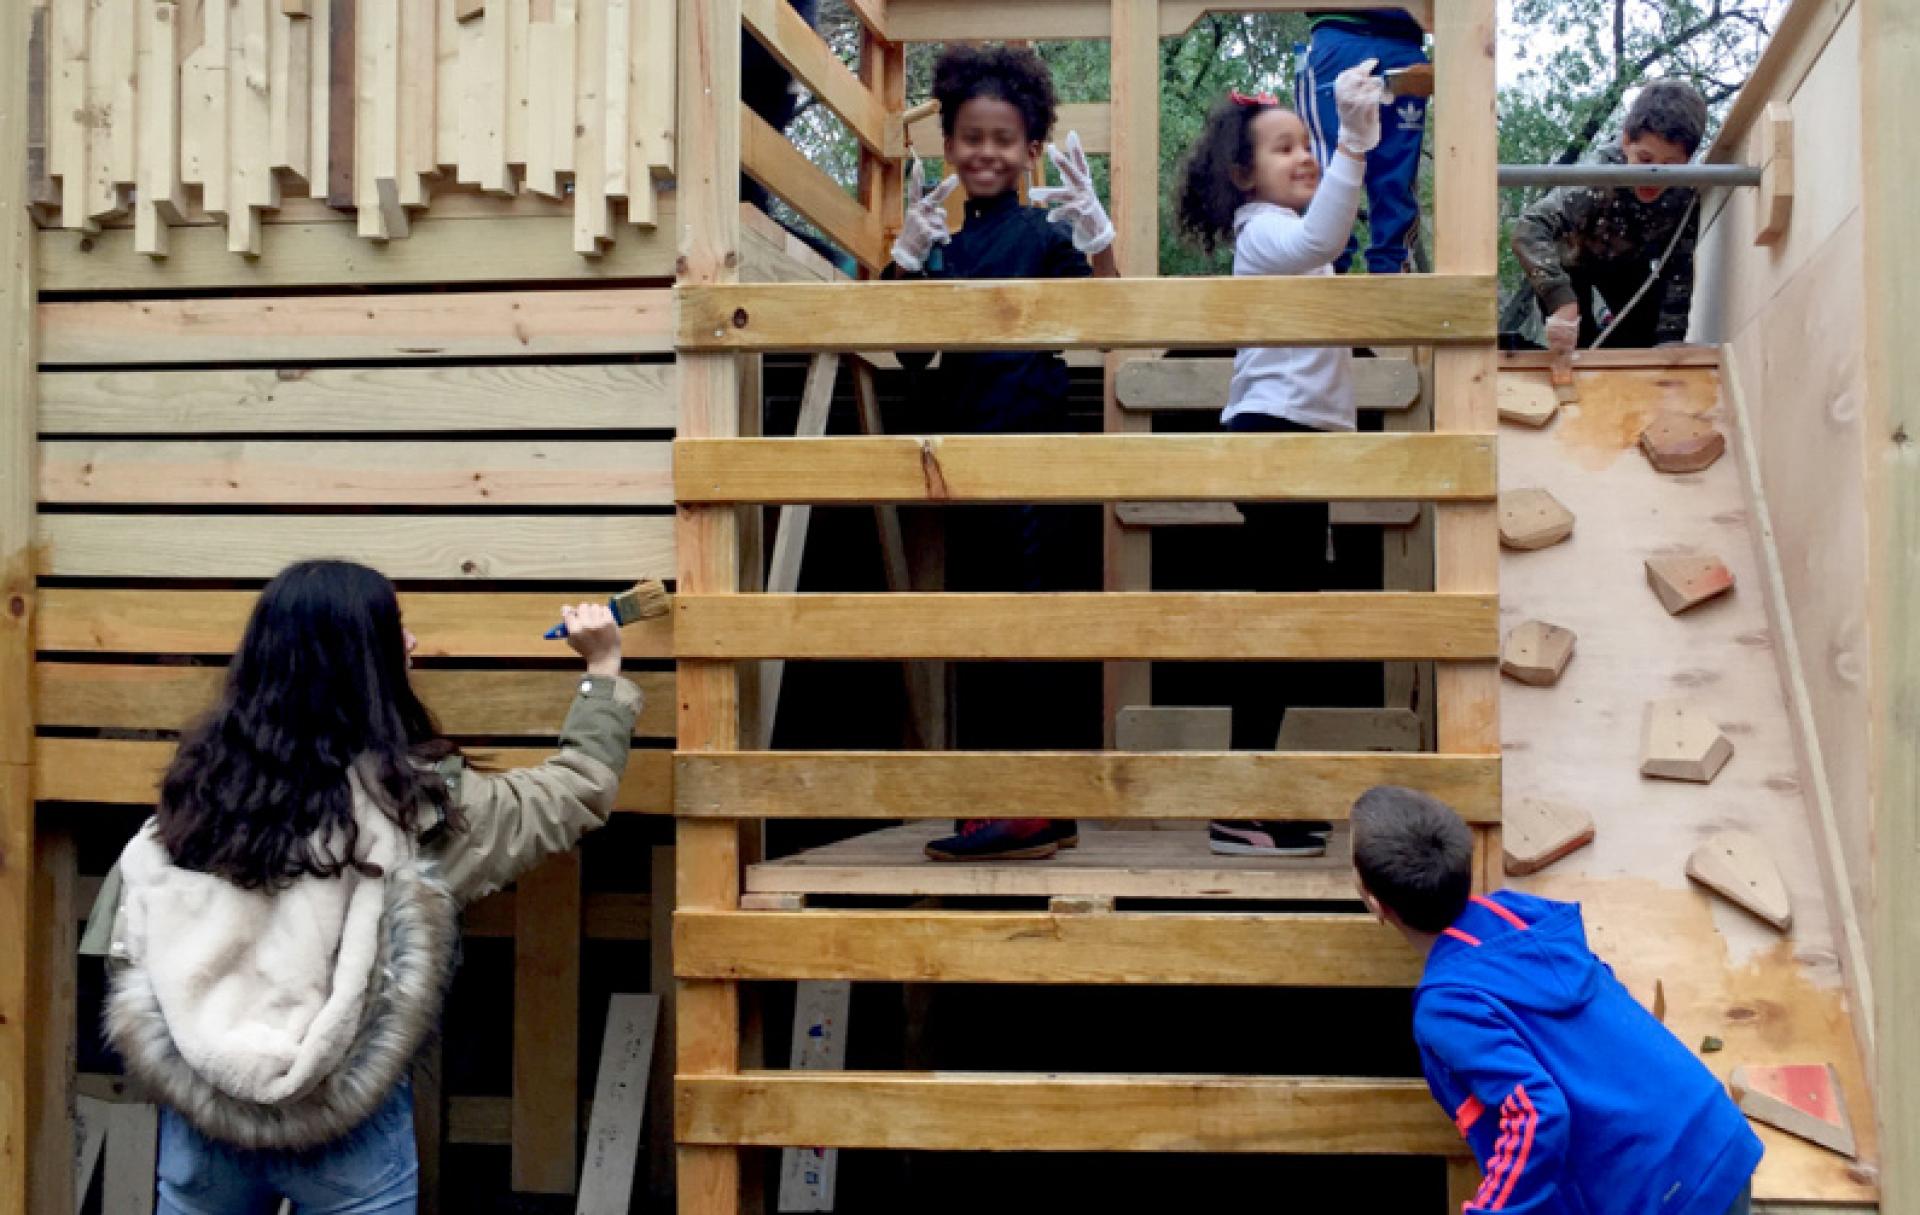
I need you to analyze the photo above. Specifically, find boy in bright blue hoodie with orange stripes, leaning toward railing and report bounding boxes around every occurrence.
[1352,785,1761,1215]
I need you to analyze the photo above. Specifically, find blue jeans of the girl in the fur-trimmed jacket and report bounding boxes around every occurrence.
[157,1084,420,1215]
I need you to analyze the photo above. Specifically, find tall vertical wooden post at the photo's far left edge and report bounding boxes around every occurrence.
[0,0,38,1215]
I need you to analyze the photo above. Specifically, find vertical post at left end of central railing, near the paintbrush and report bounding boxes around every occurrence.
[674,0,741,1215]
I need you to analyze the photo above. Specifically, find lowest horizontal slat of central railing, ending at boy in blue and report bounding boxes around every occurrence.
[674,1071,1467,1155]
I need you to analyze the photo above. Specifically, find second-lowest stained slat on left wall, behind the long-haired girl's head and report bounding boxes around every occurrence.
[33,660,674,739]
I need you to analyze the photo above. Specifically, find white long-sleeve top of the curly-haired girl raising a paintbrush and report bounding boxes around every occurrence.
[1219,154,1367,430]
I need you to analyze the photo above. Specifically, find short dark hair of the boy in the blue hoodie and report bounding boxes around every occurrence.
[1354,785,1473,933]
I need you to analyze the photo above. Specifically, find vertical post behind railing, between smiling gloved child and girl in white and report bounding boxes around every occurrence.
[1102,0,1160,747]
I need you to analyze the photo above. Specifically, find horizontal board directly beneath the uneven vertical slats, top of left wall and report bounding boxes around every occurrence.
[35,211,678,292]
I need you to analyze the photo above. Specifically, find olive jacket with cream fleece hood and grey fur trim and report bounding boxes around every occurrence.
[83,676,639,1150]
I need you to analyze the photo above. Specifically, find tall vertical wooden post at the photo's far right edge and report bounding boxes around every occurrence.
[1857,0,1920,1211]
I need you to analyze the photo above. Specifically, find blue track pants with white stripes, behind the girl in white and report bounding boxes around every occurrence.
[1294,25,1427,274]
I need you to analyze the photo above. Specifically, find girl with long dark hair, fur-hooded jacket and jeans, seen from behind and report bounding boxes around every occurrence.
[88,560,639,1215]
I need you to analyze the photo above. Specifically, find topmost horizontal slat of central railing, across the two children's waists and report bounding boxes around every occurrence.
[674,274,1496,351]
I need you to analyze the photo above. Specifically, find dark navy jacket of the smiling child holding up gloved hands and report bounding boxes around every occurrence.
[900,192,1092,434]
